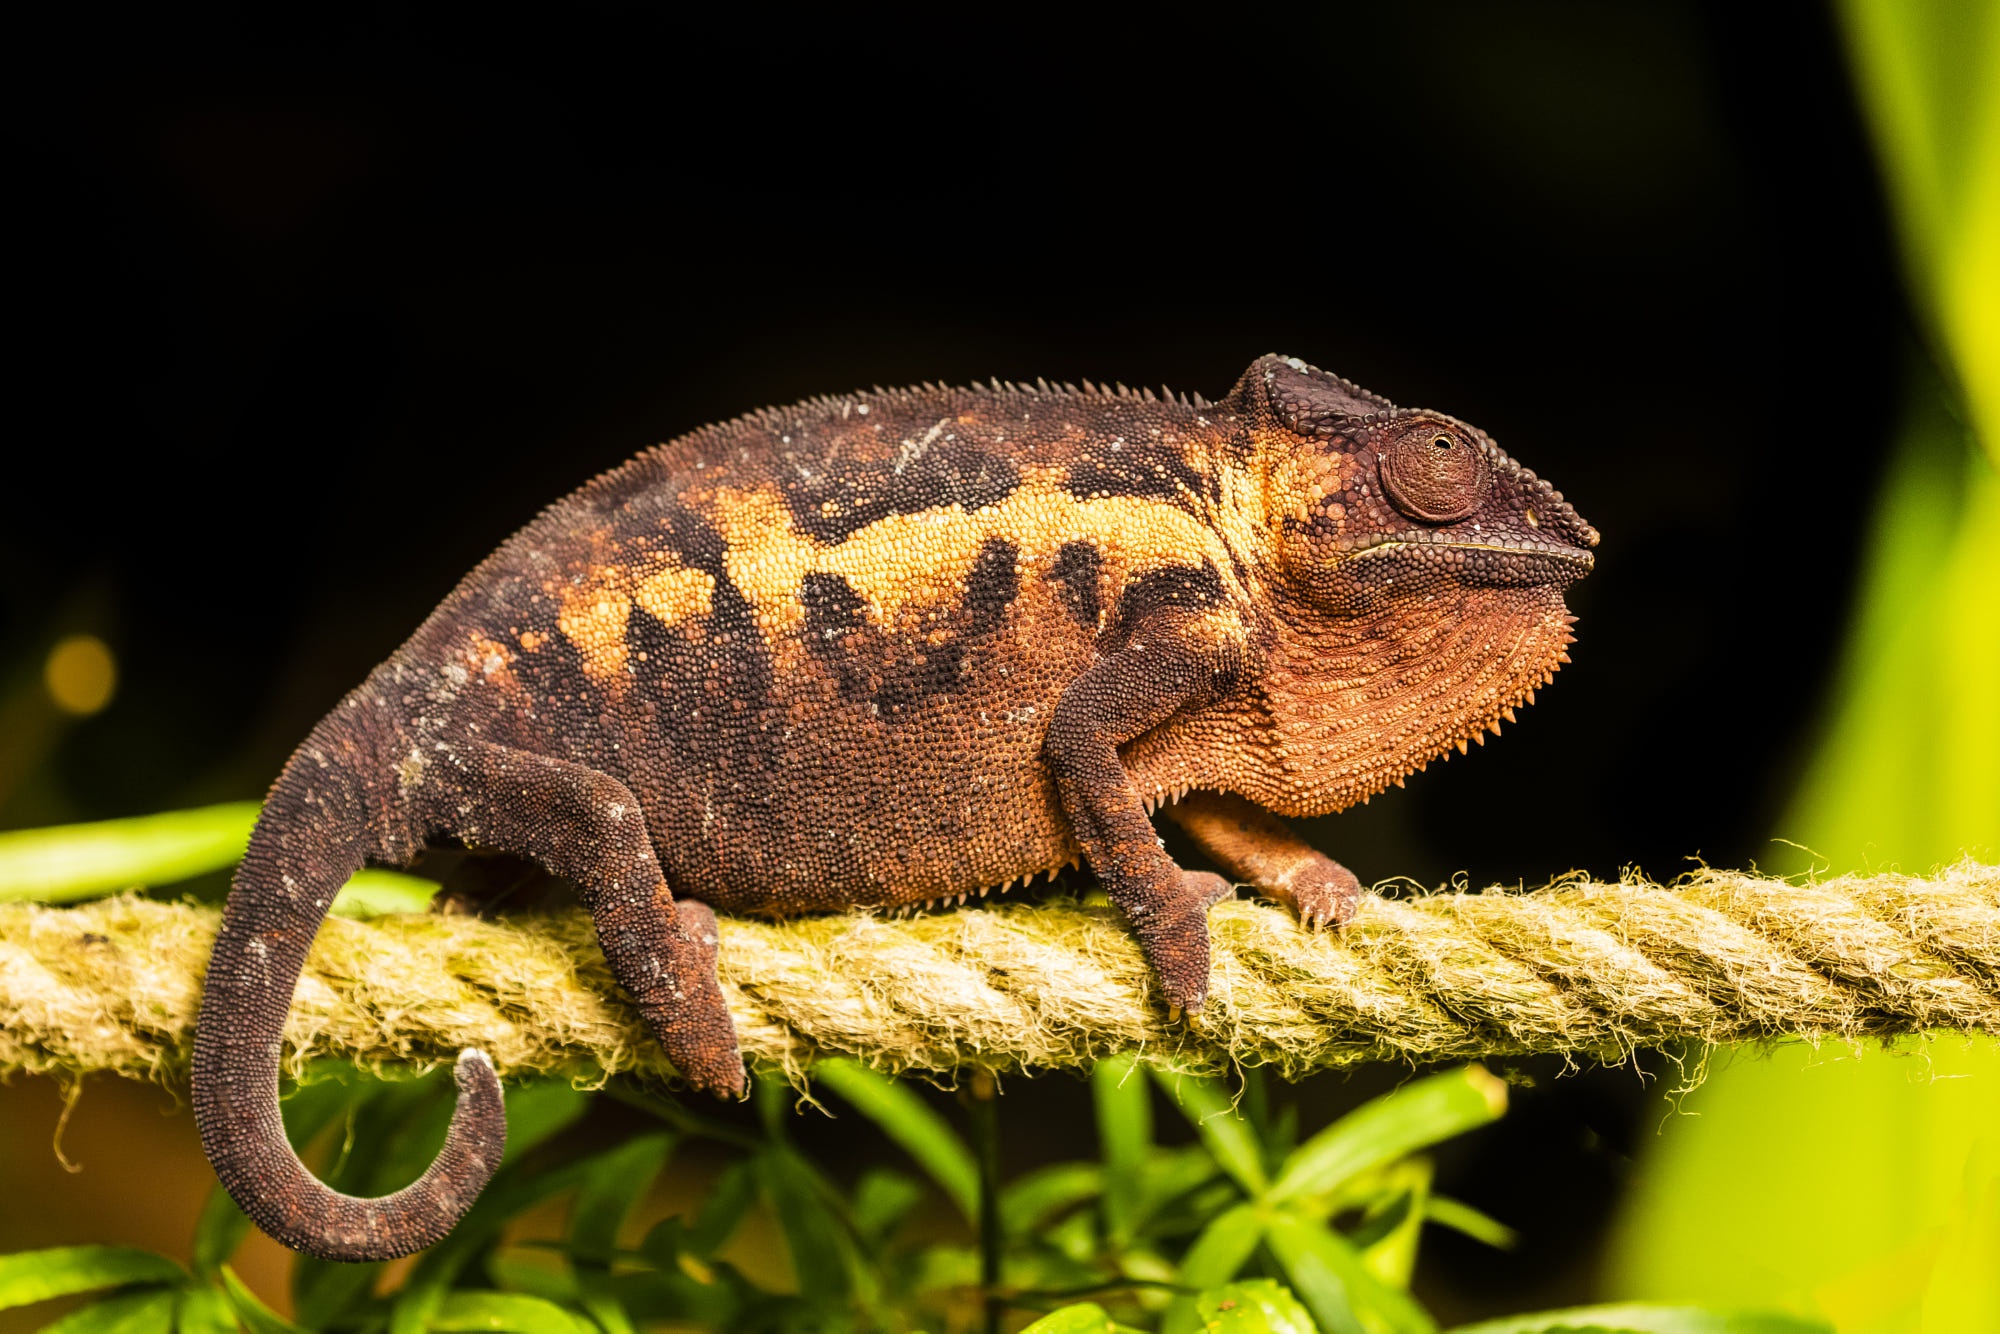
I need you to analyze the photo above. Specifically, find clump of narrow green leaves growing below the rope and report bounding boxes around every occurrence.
[0,1058,1826,1334]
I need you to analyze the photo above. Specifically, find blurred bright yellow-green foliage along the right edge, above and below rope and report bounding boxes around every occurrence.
[1608,0,2000,1334]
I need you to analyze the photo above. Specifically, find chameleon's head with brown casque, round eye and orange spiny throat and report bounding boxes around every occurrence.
[1232,356,1598,814]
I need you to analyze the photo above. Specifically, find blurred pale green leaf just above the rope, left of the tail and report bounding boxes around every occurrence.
[0,802,258,904]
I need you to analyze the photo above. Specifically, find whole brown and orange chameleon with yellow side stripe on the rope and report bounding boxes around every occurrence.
[194,356,1598,1260]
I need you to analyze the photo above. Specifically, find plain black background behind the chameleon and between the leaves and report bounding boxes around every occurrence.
[0,2,1908,1312]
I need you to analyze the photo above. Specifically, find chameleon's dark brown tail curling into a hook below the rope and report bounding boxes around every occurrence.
[192,696,506,1260]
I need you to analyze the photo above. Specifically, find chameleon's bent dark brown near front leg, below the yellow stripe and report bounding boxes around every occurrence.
[1042,626,1238,1010]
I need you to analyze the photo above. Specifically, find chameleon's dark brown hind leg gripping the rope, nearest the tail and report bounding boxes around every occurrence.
[418,742,746,1096]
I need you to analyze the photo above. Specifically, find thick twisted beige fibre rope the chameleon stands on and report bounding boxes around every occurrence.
[0,862,2000,1080]
